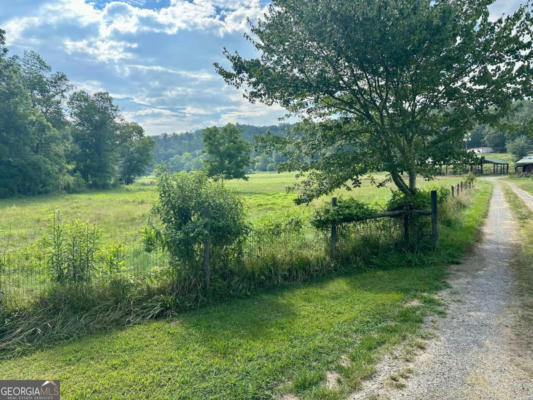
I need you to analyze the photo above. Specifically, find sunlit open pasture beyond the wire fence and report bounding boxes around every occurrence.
[0,173,459,249]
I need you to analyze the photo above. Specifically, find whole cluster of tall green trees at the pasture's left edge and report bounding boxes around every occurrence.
[0,30,155,197]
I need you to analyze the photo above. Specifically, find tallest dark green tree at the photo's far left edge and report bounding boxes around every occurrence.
[0,30,67,197]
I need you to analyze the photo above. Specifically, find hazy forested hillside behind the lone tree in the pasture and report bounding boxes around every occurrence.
[153,124,292,173]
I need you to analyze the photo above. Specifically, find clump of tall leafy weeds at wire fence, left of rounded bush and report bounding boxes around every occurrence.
[42,213,100,284]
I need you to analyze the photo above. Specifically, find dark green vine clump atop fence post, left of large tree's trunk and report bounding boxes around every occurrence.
[311,199,378,230]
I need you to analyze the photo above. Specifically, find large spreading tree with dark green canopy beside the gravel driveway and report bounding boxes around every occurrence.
[215,0,533,200]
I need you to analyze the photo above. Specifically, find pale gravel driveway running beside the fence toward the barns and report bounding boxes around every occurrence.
[352,183,533,400]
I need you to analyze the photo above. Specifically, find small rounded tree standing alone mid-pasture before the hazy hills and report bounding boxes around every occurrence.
[203,124,252,180]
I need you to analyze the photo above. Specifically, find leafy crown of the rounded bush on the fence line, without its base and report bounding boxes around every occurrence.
[145,172,248,276]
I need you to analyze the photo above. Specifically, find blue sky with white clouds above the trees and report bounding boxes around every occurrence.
[0,0,524,135]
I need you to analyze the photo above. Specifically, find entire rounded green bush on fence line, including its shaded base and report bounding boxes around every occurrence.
[144,171,248,297]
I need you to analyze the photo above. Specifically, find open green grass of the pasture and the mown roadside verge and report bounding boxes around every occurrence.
[0,174,491,399]
